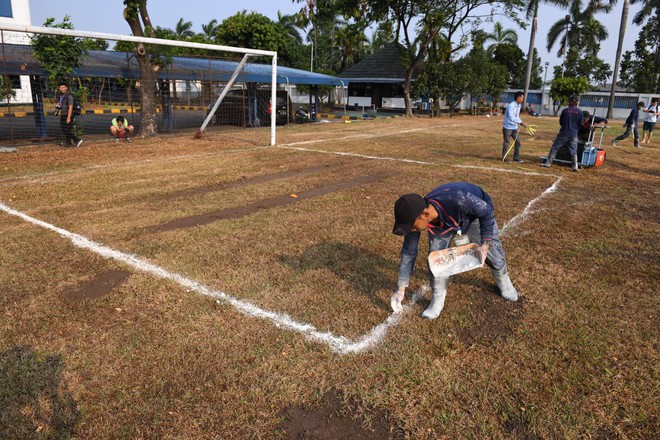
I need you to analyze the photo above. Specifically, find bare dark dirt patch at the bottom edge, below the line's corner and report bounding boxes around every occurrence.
[282,391,403,440]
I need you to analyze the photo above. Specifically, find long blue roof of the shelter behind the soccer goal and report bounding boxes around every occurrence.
[0,44,349,86]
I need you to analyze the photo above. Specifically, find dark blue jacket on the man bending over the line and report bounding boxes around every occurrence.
[424,182,495,241]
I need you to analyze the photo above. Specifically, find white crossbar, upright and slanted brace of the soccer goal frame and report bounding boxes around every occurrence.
[0,23,277,146]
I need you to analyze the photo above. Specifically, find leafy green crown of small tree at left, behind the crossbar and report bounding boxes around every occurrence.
[30,15,87,88]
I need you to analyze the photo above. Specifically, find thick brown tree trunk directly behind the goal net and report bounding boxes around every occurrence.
[124,0,164,137]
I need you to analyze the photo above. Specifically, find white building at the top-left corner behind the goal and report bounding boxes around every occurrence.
[0,0,32,103]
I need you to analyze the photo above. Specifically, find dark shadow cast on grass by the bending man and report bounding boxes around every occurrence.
[279,241,398,310]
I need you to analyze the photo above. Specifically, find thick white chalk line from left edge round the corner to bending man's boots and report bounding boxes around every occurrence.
[0,203,428,354]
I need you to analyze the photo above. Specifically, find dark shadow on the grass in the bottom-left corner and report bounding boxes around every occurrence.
[0,346,80,439]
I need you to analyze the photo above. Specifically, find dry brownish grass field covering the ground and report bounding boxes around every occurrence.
[0,116,660,439]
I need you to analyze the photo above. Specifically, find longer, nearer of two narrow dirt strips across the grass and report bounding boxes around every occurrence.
[144,174,387,233]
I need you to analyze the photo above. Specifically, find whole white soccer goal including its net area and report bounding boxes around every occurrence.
[0,23,282,145]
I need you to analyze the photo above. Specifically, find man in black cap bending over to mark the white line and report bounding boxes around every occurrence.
[390,182,518,319]
